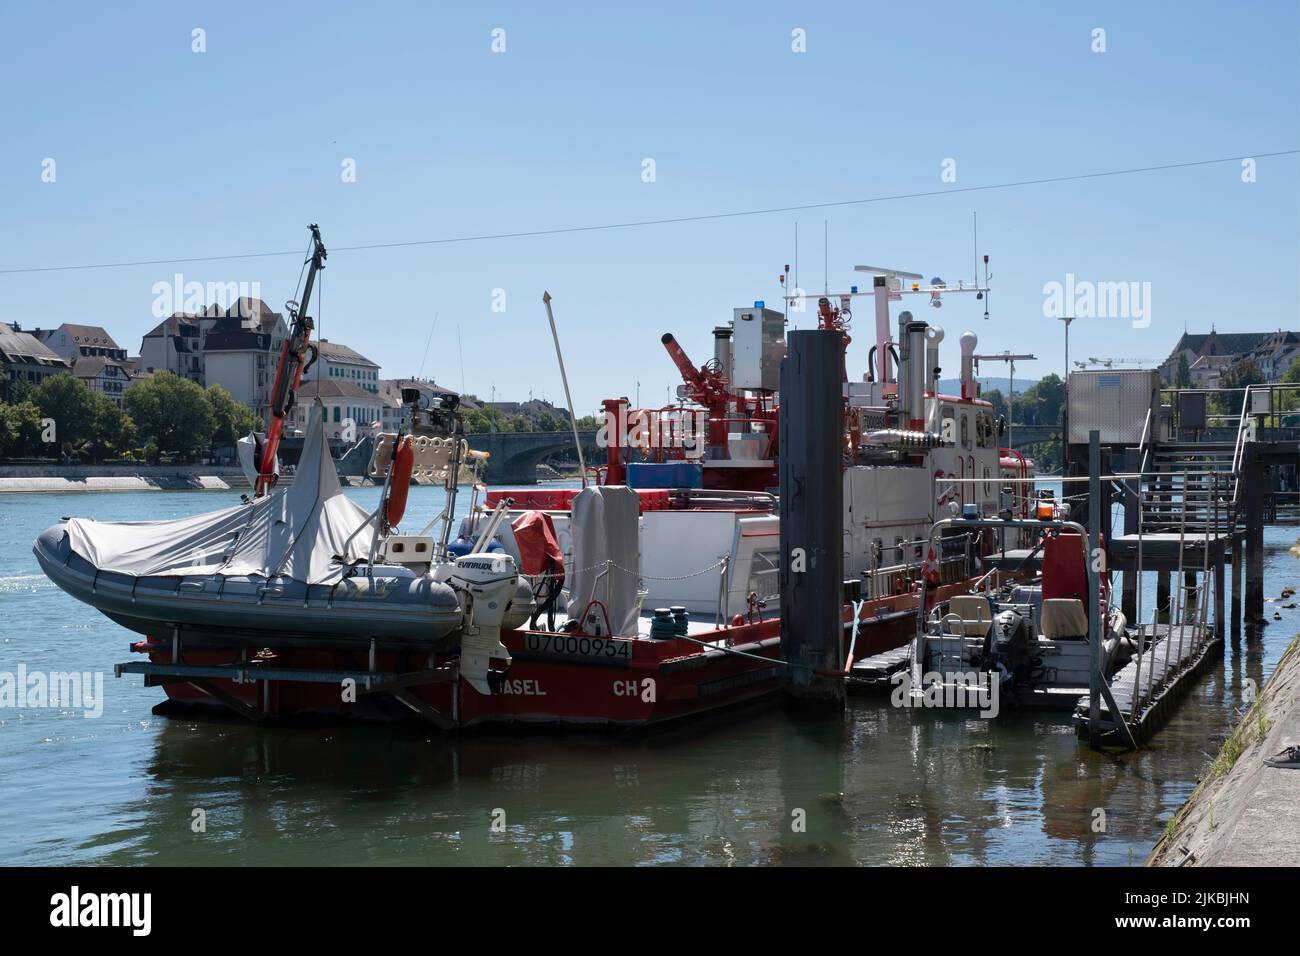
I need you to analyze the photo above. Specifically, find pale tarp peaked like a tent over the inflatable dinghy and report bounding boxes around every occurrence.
[68,401,372,584]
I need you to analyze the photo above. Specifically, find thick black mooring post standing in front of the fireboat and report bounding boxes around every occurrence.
[780,329,844,709]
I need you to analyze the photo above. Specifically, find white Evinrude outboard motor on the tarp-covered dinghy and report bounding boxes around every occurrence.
[449,551,519,695]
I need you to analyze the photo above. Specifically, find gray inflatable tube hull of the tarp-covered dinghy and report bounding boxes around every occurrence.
[33,523,533,645]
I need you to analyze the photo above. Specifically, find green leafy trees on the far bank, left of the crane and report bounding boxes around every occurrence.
[0,372,263,464]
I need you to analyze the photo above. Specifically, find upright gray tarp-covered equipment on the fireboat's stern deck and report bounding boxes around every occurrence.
[568,485,641,636]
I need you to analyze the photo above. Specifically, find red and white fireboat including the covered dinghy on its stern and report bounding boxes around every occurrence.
[36,230,1034,730]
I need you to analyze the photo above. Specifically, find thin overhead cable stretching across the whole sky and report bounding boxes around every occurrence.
[0,150,1300,276]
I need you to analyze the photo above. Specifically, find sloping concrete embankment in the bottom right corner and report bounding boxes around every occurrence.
[1147,637,1300,866]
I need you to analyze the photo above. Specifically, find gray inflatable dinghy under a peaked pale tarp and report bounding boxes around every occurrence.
[33,410,536,648]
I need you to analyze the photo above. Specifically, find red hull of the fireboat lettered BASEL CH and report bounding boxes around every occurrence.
[139,581,969,728]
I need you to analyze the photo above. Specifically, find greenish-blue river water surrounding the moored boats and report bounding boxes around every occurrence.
[0,488,1300,866]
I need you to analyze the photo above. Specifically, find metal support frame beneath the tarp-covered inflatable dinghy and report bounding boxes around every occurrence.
[113,633,460,730]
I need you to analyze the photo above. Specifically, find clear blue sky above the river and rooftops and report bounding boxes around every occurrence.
[0,0,1300,414]
